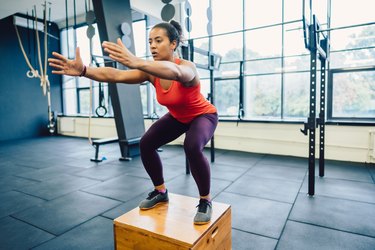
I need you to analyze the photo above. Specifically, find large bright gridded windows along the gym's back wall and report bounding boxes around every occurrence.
[57,0,375,124]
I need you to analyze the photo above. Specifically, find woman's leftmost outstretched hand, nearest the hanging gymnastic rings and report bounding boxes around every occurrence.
[48,47,84,76]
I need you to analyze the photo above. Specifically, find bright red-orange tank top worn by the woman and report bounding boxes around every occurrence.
[154,59,217,123]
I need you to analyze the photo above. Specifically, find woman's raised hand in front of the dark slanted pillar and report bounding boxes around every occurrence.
[102,38,141,69]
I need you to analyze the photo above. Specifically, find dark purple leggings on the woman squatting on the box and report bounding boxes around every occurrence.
[140,113,218,196]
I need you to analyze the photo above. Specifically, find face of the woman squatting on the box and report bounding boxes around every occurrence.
[148,28,177,61]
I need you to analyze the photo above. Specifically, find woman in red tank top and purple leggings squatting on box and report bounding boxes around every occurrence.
[49,21,218,224]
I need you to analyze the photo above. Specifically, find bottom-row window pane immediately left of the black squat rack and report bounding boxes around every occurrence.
[284,73,310,119]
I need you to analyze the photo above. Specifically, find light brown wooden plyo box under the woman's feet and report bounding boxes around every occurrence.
[114,193,232,250]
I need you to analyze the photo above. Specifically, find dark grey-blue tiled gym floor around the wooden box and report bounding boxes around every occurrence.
[0,136,375,250]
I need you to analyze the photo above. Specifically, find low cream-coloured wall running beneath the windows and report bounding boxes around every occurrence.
[58,117,375,162]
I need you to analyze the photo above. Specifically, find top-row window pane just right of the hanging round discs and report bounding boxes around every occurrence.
[212,0,244,34]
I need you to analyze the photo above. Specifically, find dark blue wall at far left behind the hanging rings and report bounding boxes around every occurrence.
[0,16,62,141]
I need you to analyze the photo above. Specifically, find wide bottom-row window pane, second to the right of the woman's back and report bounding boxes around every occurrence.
[245,75,281,120]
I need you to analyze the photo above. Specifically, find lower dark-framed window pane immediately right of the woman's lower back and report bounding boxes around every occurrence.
[215,80,240,117]
